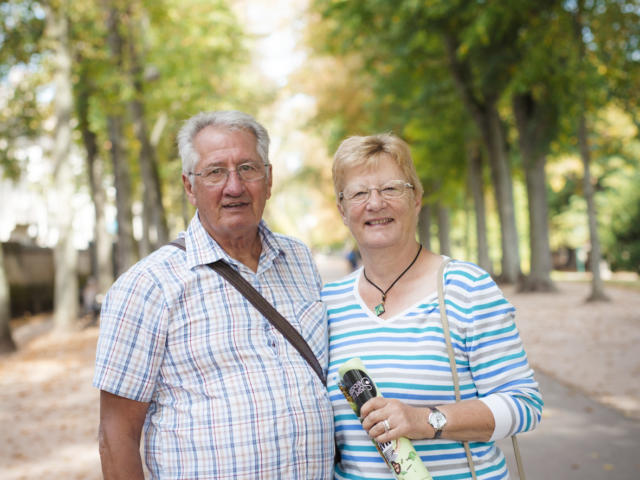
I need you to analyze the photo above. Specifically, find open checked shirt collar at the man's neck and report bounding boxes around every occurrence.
[185,212,284,273]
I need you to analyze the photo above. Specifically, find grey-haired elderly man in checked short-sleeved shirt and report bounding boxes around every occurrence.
[94,111,334,480]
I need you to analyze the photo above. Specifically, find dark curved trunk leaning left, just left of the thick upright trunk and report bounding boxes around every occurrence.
[444,34,521,283]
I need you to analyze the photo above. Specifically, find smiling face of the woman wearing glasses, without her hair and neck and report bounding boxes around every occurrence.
[338,157,421,250]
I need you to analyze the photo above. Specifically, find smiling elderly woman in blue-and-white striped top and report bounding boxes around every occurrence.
[323,134,542,479]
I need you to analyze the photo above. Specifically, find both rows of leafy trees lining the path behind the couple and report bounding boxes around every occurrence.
[0,0,640,350]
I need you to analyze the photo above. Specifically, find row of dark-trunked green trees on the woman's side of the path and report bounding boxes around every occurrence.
[308,0,640,292]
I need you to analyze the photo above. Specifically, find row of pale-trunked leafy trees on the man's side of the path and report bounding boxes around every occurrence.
[0,0,266,350]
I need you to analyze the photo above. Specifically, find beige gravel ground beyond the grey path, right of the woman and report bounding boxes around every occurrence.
[504,283,640,419]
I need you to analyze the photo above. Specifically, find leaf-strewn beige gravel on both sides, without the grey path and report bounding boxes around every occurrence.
[0,283,640,480]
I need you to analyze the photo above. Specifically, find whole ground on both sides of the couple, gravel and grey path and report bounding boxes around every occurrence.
[0,258,640,480]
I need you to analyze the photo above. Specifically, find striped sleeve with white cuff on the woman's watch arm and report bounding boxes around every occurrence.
[466,267,543,440]
